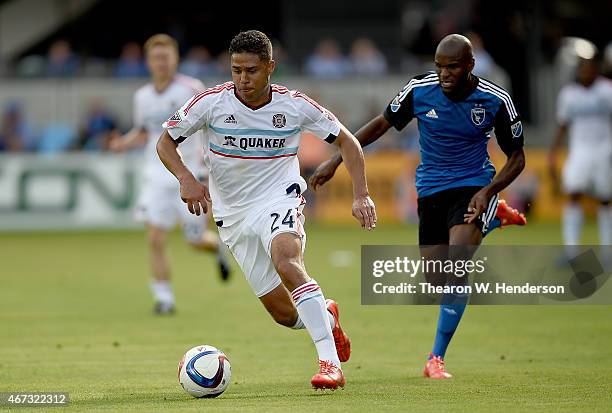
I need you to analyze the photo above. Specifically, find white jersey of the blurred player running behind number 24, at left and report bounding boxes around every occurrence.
[133,74,205,186]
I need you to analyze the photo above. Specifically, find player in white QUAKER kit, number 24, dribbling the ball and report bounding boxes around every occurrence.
[157,30,376,389]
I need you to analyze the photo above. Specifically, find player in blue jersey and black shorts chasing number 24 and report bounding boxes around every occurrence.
[310,34,525,379]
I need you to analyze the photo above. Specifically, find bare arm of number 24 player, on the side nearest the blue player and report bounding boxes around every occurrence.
[334,125,376,230]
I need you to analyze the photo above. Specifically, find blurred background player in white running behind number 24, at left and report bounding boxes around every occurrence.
[110,34,229,314]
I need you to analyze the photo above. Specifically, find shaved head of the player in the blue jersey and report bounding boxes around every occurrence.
[434,34,477,96]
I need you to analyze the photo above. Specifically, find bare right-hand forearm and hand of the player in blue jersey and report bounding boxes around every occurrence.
[464,148,525,223]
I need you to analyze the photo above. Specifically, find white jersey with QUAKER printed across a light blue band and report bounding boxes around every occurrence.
[164,82,340,226]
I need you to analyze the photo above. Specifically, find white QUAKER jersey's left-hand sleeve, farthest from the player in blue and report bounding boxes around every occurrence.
[163,90,212,143]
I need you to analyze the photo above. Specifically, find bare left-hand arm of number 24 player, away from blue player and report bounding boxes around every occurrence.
[157,130,211,215]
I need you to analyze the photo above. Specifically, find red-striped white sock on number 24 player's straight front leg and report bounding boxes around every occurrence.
[291,280,340,367]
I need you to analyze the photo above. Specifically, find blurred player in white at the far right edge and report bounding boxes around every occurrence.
[549,58,612,251]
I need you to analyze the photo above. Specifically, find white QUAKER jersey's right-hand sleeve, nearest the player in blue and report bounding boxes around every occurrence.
[291,91,340,143]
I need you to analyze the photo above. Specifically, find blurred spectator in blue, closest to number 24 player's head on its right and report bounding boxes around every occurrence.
[304,39,351,79]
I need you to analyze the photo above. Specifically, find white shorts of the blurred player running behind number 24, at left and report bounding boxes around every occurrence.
[135,182,208,243]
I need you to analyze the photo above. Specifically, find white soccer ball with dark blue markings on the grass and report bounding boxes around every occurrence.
[178,345,232,398]
